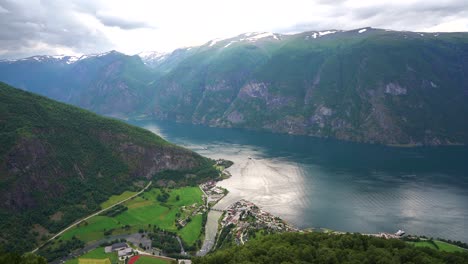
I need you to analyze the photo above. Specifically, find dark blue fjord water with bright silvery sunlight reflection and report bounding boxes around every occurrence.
[131,121,468,242]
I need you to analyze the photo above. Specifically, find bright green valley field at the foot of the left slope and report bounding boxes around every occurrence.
[56,187,202,245]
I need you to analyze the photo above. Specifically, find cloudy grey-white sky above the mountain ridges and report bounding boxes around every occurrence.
[0,0,468,58]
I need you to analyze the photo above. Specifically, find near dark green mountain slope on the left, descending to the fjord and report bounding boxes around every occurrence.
[0,83,214,251]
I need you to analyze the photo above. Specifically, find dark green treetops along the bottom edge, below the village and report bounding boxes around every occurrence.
[193,233,468,264]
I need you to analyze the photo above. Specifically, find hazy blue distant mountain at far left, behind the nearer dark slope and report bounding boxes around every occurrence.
[0,51,158,116]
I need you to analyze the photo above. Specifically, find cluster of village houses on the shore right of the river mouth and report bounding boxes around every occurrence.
[221,200,298,244]
